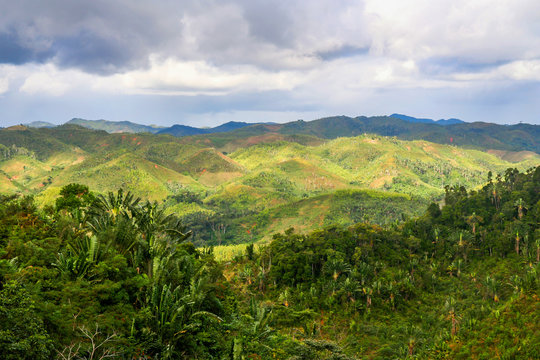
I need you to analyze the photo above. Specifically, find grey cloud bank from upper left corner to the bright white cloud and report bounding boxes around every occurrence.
[0,0,372,74]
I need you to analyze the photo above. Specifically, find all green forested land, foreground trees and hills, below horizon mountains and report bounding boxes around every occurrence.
[0,125,540,360]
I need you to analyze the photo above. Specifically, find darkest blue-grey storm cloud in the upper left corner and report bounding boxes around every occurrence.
[0,0,192,73]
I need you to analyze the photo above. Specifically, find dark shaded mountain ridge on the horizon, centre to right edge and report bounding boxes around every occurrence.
[188,116,540,153]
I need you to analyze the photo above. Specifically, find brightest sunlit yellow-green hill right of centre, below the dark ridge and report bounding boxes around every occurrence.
[231,135,540,197]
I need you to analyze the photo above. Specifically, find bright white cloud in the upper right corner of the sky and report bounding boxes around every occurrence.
[366,0,540,63]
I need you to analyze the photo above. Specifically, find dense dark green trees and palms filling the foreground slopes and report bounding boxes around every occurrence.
[0,167,540,359]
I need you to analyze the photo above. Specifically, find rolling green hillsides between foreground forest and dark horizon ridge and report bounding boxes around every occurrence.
[0,124,540,244]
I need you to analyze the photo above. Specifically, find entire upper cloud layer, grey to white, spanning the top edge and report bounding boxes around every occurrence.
[0,0,540,74]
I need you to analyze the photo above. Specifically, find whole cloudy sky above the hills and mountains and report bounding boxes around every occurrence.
[0,0,540,126]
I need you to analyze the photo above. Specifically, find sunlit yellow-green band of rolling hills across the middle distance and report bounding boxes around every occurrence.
[4,135,540,210]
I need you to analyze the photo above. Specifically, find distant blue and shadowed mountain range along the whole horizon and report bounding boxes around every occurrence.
[22,114,540,153]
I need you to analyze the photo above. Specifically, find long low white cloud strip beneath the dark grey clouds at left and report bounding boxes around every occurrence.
[11,57,303,96]
